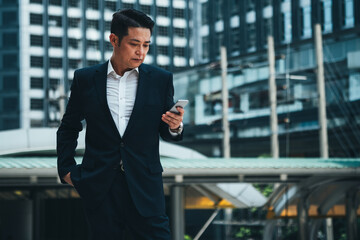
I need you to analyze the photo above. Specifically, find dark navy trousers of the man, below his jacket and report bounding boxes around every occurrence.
[85,168,171,240]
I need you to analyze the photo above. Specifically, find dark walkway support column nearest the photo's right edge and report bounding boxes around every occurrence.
[346,191,359,240]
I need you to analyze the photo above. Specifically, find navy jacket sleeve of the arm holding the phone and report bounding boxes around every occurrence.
[160,73,184,141]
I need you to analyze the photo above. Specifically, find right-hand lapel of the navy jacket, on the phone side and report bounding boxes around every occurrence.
[123,64,151,138]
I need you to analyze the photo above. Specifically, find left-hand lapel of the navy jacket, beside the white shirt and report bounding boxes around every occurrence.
[94,61,121,138]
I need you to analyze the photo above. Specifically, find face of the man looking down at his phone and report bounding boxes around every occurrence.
[113,28,151,69]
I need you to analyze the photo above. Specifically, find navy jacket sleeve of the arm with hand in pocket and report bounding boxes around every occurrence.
[56,72,84,183]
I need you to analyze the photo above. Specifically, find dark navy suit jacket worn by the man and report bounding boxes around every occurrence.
[57,62,182,217]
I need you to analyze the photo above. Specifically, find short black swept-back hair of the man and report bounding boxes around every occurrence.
[110,9,155,42]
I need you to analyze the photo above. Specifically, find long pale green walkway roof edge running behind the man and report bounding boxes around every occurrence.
[0,157,360,183]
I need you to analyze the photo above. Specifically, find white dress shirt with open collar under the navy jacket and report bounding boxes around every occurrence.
[106,60,180,136]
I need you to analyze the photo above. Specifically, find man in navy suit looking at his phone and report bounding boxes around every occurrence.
[57,9,184,240]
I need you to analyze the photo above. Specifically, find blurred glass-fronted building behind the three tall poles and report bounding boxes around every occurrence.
[175,0,360,157]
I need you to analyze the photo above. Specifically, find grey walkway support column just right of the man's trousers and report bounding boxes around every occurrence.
[171,185,185,240]
